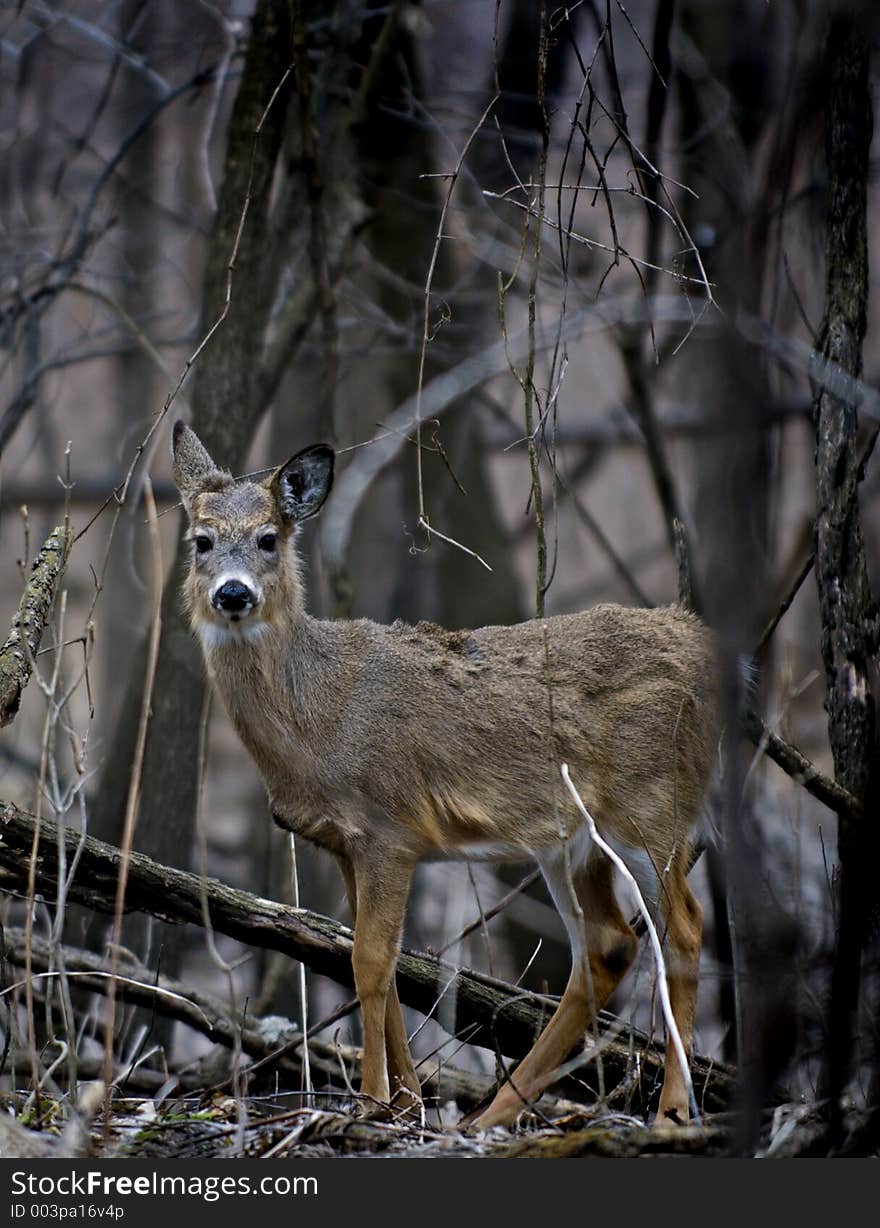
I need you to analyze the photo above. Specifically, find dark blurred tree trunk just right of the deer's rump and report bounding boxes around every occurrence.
[676,2,775,1152]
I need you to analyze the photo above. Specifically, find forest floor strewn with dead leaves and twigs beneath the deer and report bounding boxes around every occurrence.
[0,1084,859,1162]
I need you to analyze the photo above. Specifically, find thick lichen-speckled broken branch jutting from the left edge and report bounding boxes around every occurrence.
[0,524,74,727]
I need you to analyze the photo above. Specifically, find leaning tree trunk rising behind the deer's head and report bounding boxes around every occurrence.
[91,0,291,971]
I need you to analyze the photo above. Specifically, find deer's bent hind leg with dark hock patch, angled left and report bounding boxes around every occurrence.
[474,855,637,1127]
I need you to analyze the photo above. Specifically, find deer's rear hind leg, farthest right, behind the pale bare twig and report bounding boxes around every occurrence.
[657,865,703,1125]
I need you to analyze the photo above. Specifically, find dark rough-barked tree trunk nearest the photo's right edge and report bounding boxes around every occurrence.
[814,11,880,1140]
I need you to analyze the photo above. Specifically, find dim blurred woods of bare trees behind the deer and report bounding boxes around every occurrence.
[0,0,880,1154]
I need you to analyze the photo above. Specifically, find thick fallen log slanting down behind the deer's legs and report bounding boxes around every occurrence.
[0,803,734,1113]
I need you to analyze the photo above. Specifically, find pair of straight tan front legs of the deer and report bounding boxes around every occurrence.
[351,858,420,1104]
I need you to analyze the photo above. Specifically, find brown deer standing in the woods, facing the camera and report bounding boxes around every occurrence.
[172,421,719,1129]
